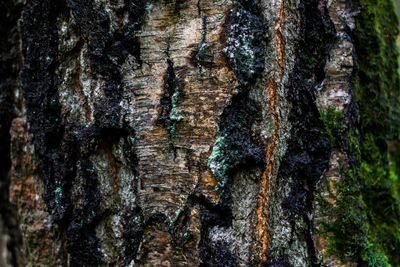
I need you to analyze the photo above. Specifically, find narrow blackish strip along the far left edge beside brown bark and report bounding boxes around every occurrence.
[0,1,23,266]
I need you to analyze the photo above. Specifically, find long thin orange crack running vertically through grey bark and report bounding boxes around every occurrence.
[256,0,285,262]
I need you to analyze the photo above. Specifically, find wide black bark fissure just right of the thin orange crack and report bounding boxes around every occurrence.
[268,1,334,266]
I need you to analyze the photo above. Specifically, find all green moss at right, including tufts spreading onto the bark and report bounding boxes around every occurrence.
[318,0,400,266]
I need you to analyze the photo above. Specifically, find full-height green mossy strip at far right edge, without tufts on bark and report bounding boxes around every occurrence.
[355,0,400,266]
